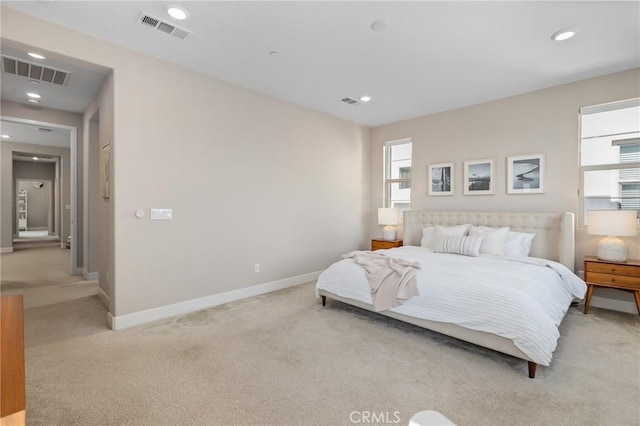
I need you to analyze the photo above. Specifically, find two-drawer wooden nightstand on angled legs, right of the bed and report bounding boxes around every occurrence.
[584,256,640,314]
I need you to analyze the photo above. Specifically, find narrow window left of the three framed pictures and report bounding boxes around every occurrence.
[384,139,411,212]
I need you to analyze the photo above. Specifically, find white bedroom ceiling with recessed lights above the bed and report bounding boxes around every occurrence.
[2,1,640,126]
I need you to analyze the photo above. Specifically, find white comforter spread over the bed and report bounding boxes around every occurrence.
[316,246,586,365]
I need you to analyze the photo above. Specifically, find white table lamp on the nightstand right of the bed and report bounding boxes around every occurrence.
[587,210,638,262]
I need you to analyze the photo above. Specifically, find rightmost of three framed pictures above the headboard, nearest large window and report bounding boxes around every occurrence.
[507,154,544,194]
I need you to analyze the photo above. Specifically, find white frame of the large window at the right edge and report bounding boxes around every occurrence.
[577,98,640,229]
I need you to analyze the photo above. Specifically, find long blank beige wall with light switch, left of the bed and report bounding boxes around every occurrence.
[2,8,370,316]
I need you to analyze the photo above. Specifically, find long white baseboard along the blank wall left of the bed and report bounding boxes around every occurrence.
[107,271,322,330]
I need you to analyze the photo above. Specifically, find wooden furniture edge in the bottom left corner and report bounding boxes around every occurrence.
[0,296,26,426]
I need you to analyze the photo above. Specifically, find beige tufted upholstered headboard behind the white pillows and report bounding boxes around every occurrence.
[403,210,575,271]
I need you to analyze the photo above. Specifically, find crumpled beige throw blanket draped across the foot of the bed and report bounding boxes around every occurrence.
[342,251,420,312]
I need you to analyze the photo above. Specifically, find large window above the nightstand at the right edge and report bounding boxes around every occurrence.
[580,99,640,225]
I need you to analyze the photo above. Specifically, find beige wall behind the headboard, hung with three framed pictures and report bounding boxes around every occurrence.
[369,69,640,310]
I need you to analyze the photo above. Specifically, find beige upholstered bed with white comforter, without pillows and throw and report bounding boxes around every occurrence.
[316,211,586,378]
